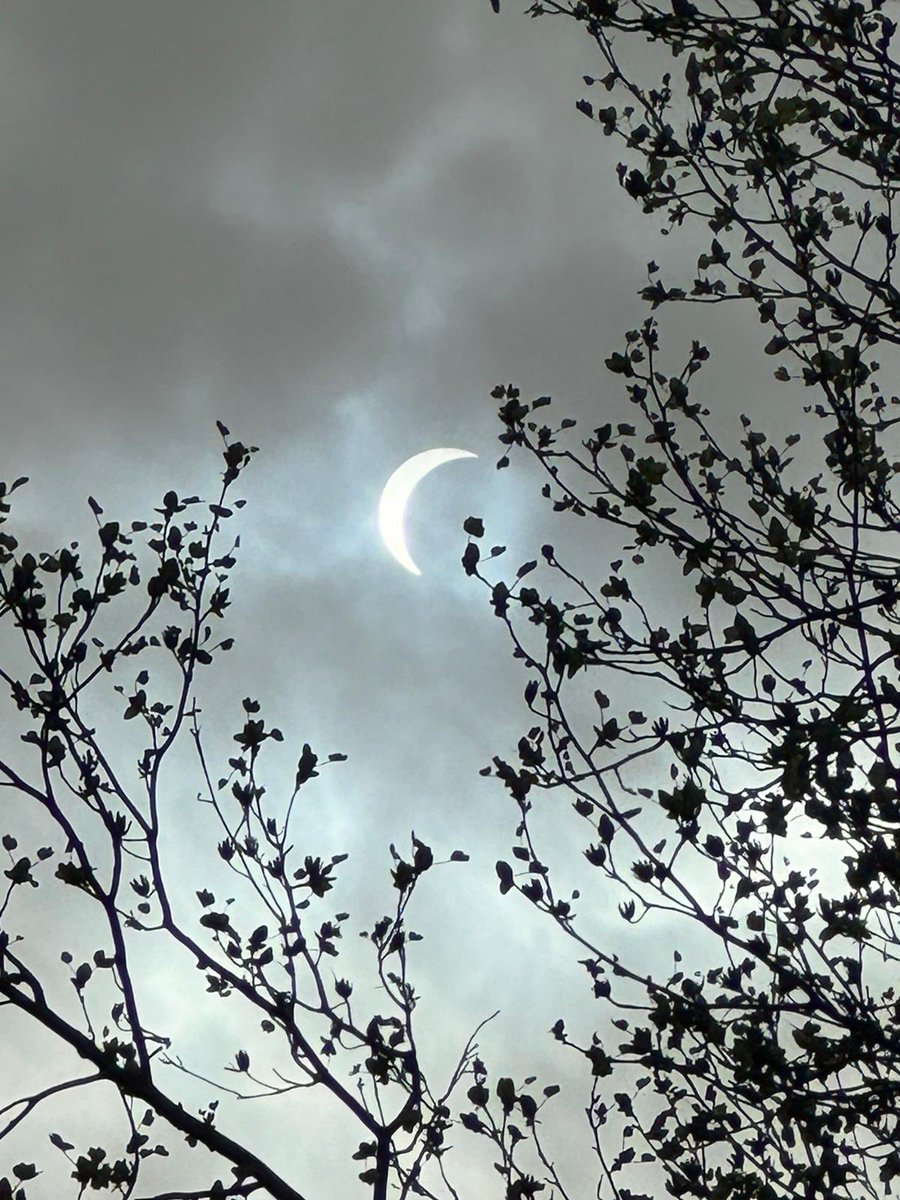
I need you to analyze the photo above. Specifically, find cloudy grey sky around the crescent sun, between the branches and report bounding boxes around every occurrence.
[0,0,816,1198]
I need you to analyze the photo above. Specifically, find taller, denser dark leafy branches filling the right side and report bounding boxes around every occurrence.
[463,0,900,1200]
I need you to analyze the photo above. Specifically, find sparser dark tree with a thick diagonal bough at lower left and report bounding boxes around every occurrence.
[0,424,482,1200]
